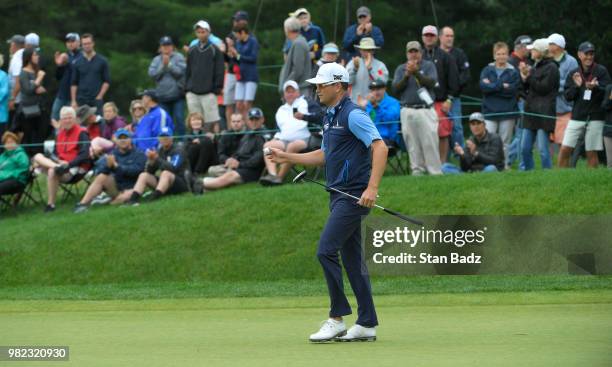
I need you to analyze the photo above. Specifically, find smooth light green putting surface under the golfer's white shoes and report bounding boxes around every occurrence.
[0,290,612,367]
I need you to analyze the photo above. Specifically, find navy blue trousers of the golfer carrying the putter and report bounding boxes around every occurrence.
[317,192,378,327]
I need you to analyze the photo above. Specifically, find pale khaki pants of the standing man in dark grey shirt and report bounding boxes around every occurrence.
[400,107,442,176]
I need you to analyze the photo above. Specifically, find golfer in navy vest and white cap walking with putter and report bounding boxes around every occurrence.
[268,63,387,342]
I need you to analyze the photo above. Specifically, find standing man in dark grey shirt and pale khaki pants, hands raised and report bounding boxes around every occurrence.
[393,41,442,176]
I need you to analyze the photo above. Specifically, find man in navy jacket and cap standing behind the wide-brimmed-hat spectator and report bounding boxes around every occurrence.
[342,6,385,64]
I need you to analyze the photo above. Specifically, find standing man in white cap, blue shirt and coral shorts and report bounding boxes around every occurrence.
[548,33,578,151]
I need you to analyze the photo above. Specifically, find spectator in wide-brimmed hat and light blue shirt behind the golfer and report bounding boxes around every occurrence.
[346,37,389,104]
